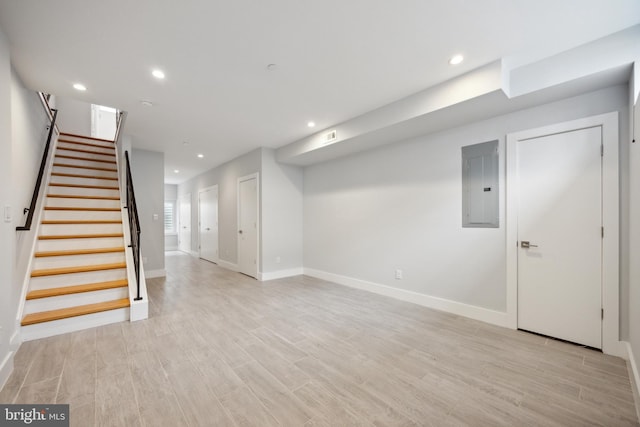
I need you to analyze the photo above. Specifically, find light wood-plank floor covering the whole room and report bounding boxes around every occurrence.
[0,253,639,427]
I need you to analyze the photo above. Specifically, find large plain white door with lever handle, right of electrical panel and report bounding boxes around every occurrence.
[517,126,602,348]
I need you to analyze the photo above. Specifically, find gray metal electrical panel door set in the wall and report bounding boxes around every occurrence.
[462,140,500,228]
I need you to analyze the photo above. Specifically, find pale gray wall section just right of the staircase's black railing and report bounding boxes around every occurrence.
[129,149,164,278]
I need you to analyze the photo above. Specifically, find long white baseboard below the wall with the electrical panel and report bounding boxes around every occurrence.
[304,267,507,326]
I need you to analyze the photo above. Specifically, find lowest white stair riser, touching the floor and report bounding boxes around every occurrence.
[20,307,129,341]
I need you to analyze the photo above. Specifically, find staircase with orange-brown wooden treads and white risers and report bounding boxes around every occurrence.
[21,133,129,341]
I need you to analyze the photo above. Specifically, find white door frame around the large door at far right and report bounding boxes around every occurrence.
[506,111,626,357]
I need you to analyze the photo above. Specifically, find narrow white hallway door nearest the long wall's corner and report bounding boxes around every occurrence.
[238,176,258,278]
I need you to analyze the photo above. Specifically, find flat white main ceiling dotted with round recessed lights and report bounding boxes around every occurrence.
[0,0,640,183]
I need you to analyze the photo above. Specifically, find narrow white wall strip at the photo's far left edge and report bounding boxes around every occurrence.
[0,22,18,387]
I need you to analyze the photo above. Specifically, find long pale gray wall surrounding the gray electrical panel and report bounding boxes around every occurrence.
[304,86,628,321]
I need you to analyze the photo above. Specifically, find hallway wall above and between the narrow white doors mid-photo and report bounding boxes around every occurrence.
[178,149,262,268]
